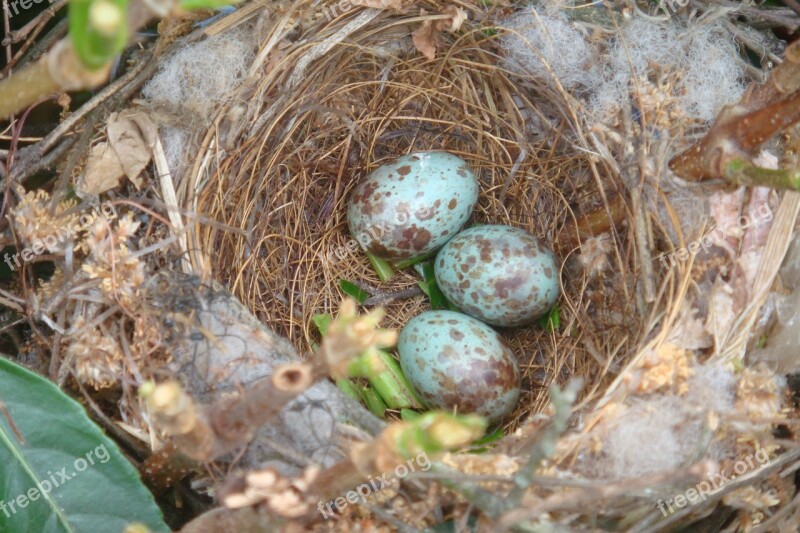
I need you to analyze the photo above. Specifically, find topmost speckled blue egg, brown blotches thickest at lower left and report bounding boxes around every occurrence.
[347,152,478,261]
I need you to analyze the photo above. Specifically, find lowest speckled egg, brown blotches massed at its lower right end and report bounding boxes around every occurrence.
[397,311,520,422]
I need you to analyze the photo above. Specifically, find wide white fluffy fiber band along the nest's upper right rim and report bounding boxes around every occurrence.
[501,5,745,121]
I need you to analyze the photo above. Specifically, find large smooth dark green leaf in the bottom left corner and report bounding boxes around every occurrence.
[0,358,169,533]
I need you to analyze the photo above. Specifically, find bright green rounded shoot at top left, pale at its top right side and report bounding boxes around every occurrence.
[68,0,128,69]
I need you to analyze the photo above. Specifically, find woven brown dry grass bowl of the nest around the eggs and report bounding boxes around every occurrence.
[180,5,641,425]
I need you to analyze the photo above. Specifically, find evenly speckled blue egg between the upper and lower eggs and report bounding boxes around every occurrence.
[435,225,560,326]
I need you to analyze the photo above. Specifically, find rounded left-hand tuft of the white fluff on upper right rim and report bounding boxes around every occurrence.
[502,9,595,89]
